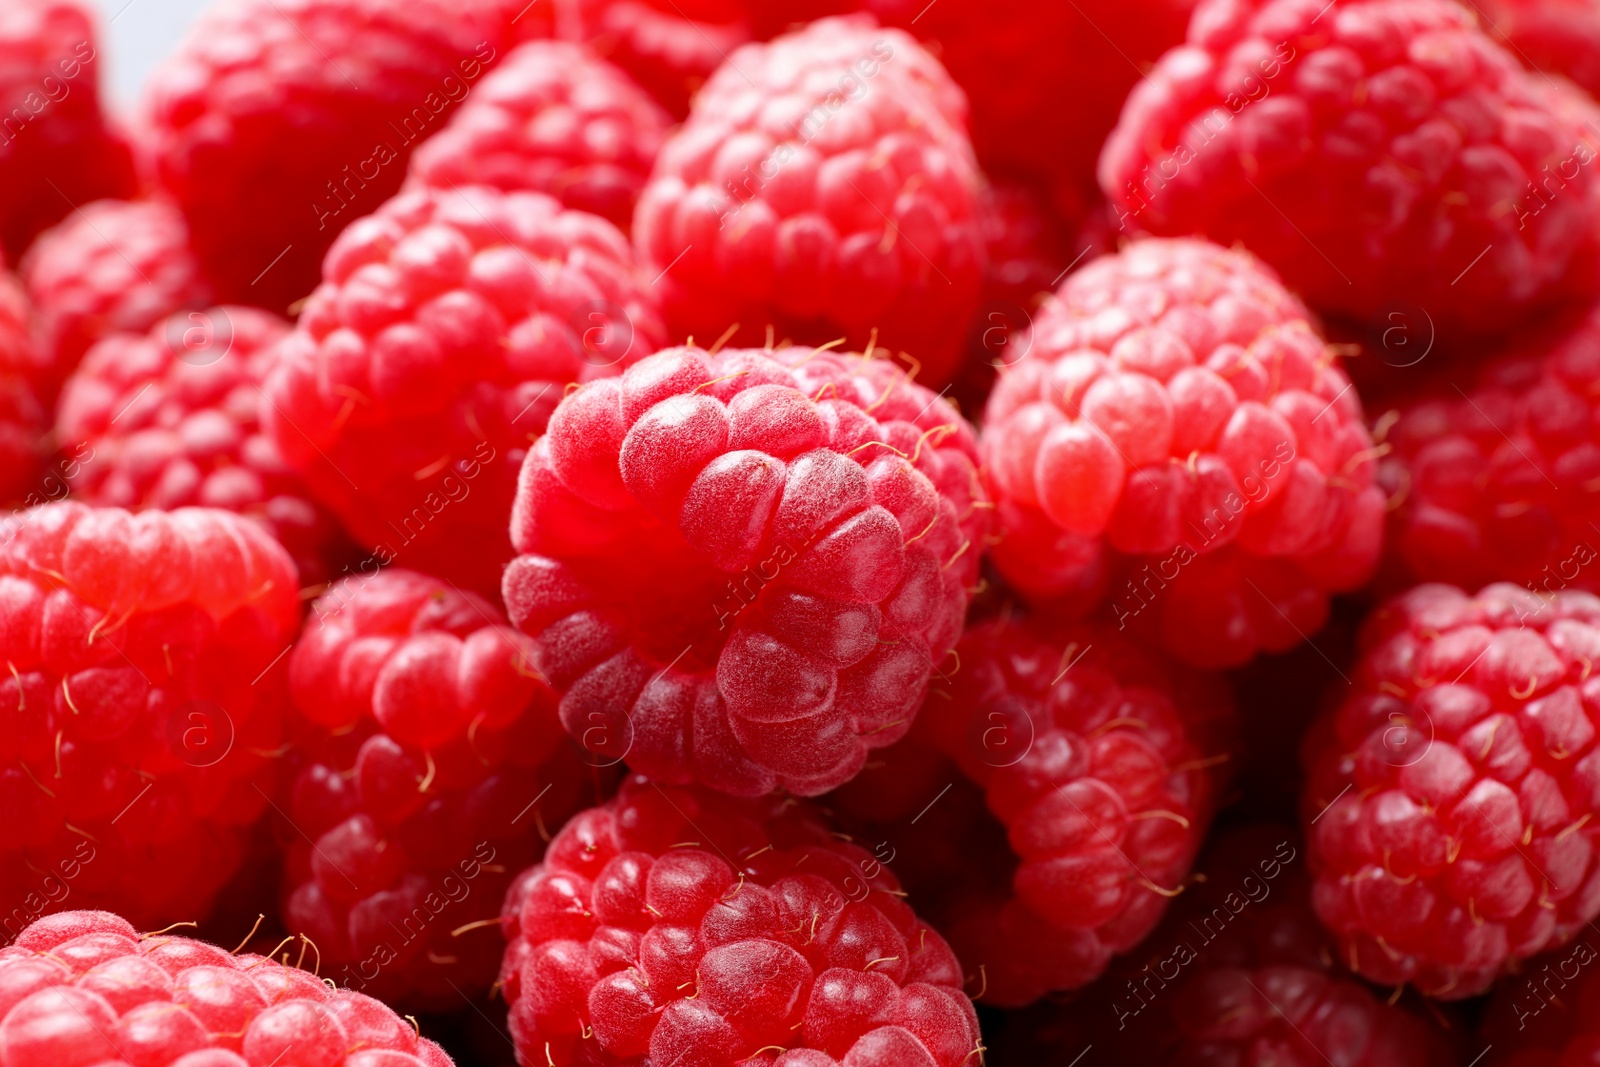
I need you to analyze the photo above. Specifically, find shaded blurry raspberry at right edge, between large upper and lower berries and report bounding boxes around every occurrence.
[1376,309,1600,593]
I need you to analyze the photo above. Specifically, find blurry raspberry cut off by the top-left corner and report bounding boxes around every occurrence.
[0,0,134,264]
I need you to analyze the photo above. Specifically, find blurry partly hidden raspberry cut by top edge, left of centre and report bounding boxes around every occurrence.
[557,0,757,118]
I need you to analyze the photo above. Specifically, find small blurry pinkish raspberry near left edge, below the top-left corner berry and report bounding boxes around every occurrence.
[21,200,211,390]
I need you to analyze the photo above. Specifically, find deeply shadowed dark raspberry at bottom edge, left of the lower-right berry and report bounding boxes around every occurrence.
[986,825,1470,1067]
